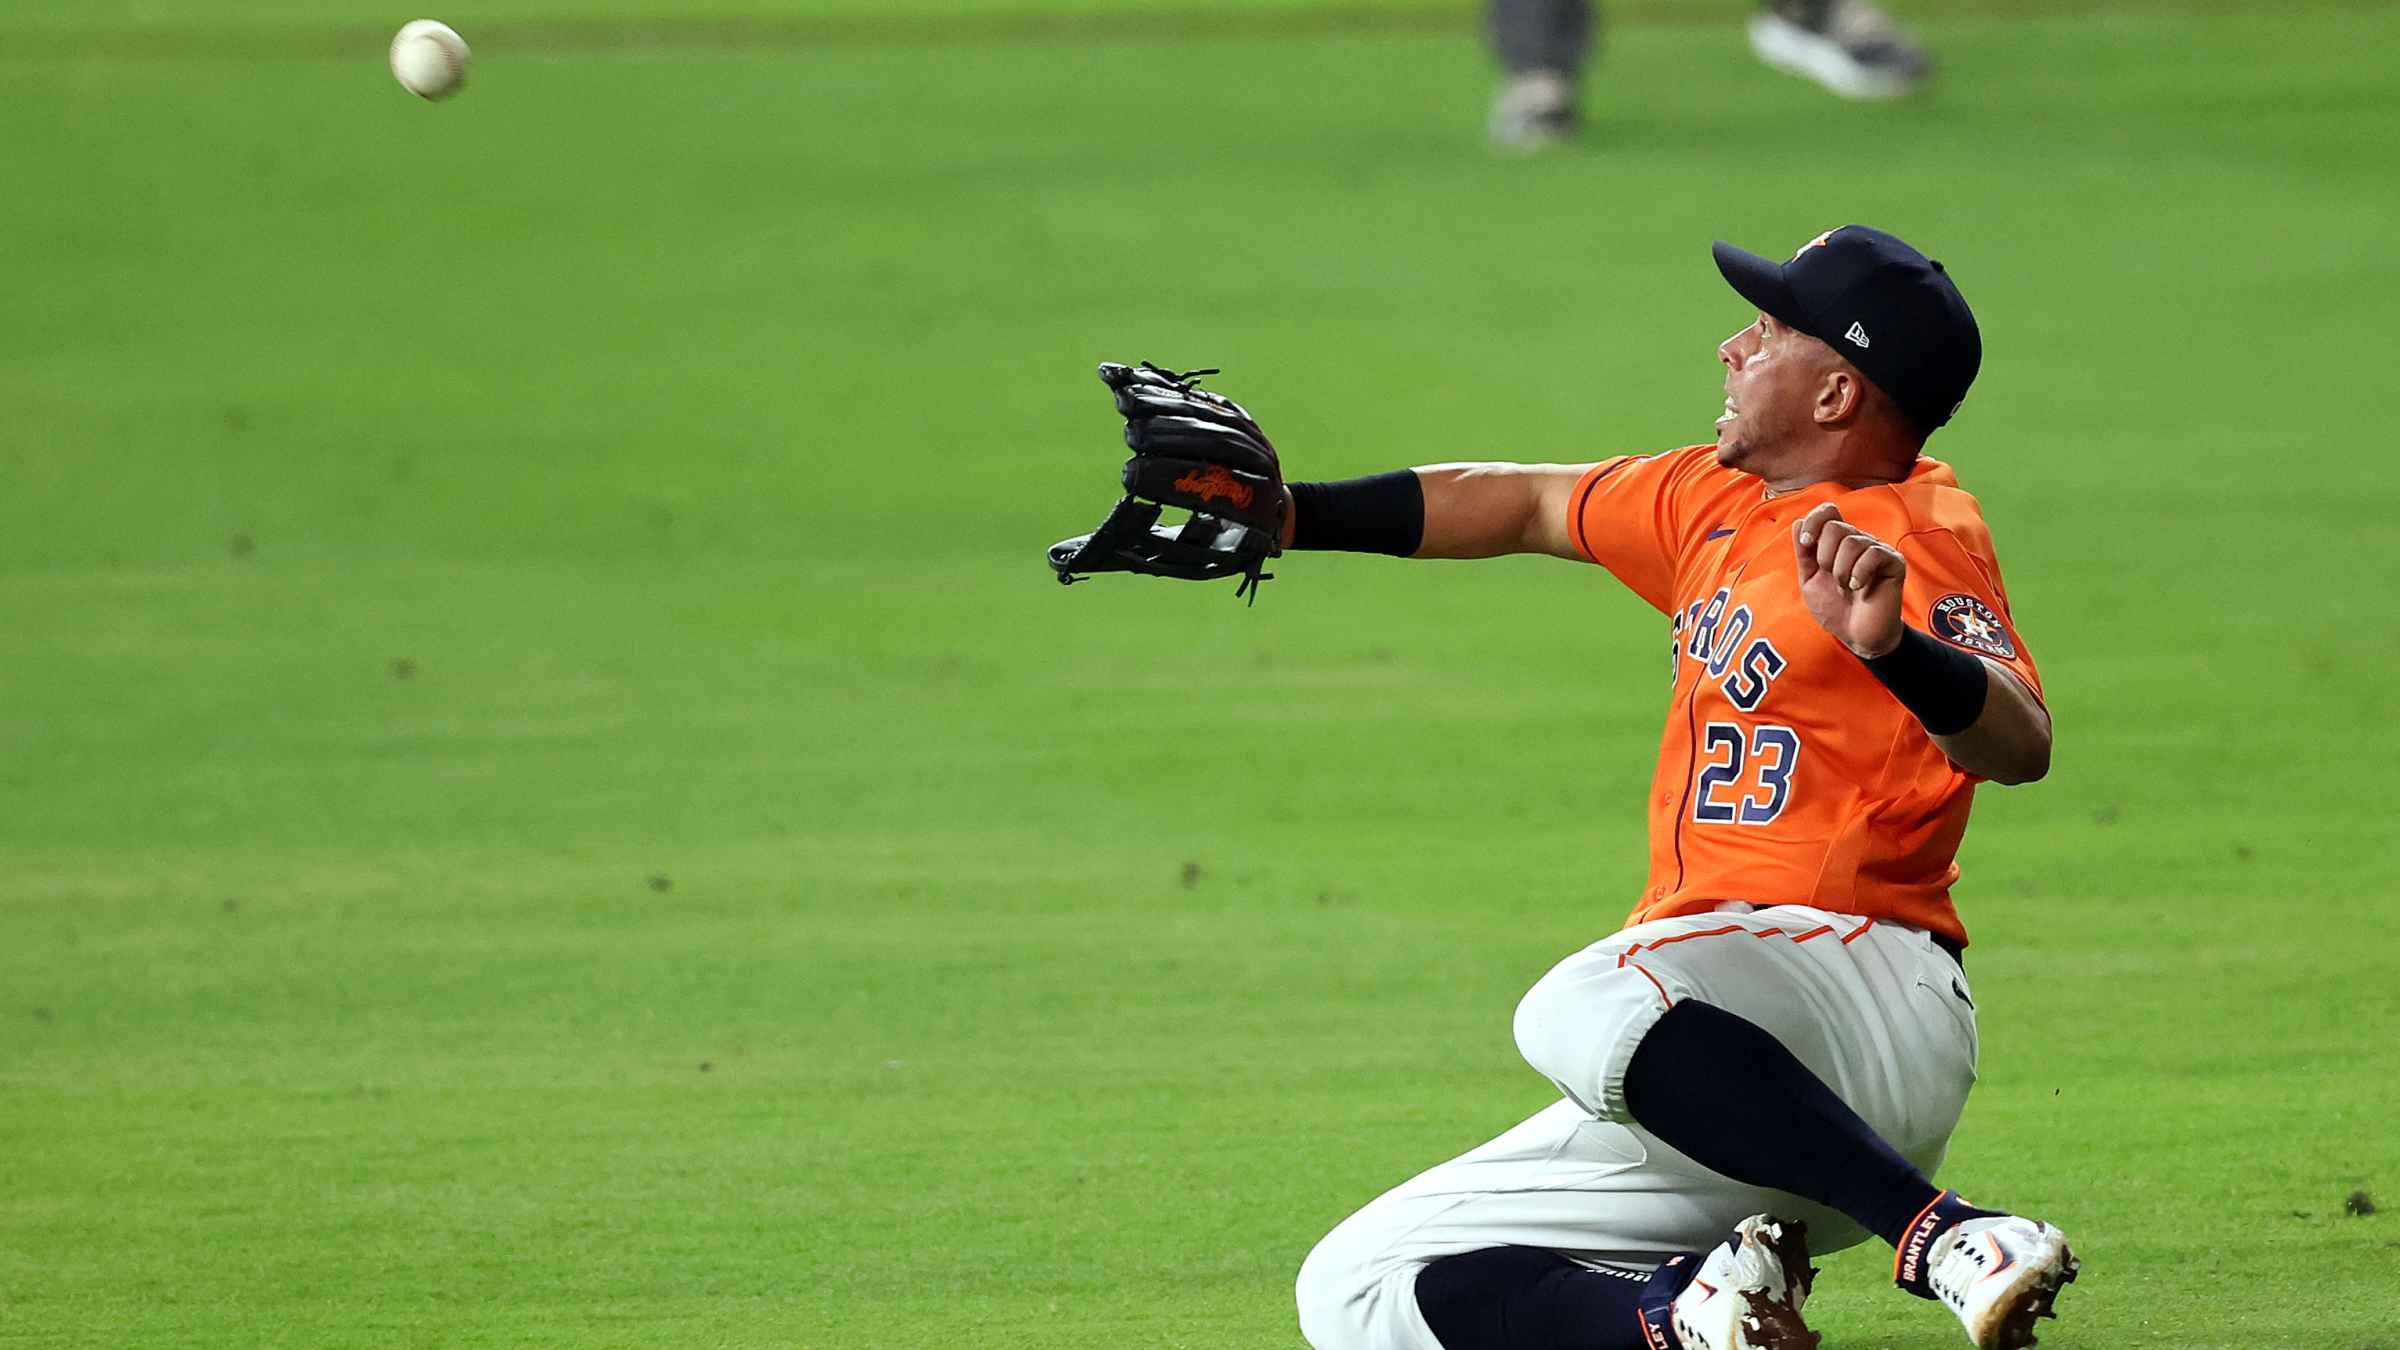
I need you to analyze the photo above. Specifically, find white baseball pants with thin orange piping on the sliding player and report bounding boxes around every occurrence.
[1298,906,1975,1350]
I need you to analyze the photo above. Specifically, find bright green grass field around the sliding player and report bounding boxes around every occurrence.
[0,0,2400,1350]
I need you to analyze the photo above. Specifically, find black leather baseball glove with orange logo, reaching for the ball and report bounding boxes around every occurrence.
[1049,360,1284,603]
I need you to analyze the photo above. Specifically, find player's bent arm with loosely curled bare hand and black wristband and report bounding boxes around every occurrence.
[1793,502,2050,783]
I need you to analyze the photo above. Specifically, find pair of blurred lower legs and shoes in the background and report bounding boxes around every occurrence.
[1483,0,1934,149]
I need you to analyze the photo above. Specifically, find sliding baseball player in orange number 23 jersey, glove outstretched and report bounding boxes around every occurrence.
[1051,226,2076,1350]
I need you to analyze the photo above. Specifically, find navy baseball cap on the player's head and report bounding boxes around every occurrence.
[1711,226,1982,432]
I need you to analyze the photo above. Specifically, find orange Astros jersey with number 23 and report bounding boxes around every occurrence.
[1567,444,2042,942]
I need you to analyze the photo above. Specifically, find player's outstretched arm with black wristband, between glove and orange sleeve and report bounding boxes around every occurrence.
[1282,464,1591,557]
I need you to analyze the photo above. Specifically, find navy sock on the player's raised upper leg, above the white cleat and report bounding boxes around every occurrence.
[1625,999,1942,1247]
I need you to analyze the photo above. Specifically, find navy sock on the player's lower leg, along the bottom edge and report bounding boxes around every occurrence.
[1416,1247,1651,1350]
